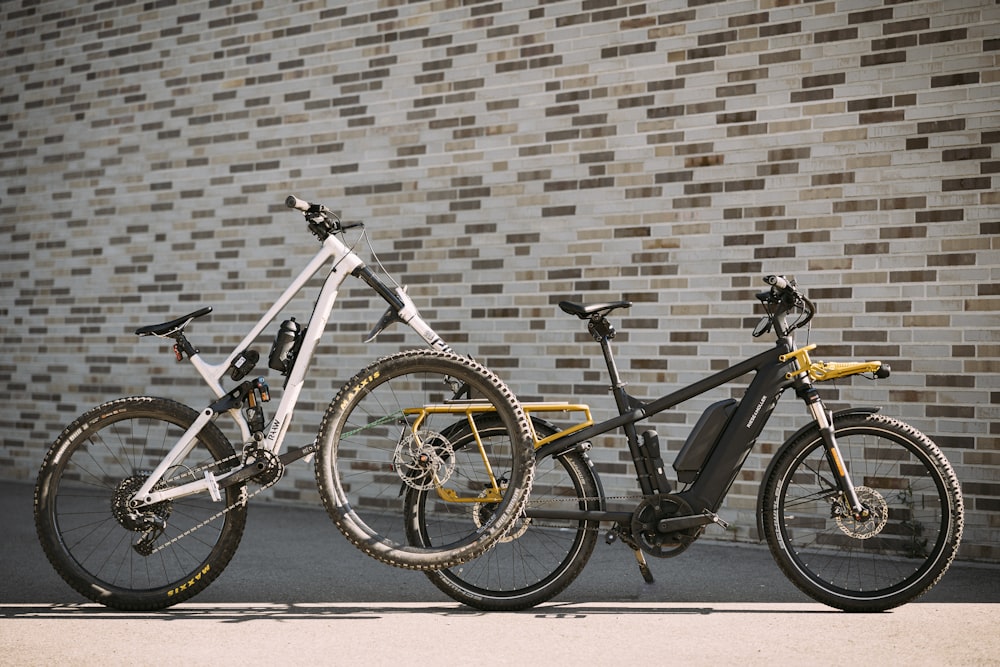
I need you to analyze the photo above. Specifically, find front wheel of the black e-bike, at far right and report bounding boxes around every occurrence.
[762,414,964,611]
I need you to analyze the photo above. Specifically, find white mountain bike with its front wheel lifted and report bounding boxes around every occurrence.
[34,197,534,610]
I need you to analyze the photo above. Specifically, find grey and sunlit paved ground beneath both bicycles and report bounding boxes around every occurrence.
[0,482,1000,666]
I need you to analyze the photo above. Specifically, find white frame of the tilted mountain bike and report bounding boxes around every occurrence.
[131,222,451,509]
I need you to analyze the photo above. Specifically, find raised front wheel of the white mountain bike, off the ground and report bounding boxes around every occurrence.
[316,350,534,570]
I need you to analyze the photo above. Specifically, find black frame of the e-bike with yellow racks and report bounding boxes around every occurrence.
[527,337,794,522]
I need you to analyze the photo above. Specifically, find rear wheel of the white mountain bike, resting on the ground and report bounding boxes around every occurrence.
[35,397,246,611]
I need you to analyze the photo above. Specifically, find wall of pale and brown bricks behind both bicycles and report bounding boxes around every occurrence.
[0,0,1000,560]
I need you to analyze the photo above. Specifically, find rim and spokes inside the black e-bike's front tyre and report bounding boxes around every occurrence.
[776,427,951,599]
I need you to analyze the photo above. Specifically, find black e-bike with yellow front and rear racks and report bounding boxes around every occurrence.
[405,276,964,611]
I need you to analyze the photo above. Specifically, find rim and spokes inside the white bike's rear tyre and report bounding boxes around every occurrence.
[41,411,244,596]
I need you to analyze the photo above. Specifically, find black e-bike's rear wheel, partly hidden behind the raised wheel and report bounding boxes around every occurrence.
[406,418,602,611]
